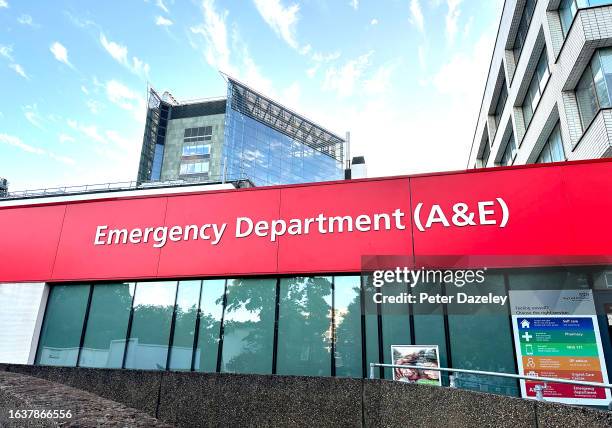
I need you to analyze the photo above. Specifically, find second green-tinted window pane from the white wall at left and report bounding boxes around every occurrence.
[79,283,134,368]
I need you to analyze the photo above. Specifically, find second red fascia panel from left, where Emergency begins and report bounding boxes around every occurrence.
[51,198,167,280]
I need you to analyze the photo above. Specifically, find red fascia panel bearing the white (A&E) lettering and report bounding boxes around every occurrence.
[411,167,582,267]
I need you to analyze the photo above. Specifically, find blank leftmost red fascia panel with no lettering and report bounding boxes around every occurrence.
[0,205,66,282]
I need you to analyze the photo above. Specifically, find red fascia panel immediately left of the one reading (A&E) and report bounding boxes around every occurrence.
[278,178,412,273]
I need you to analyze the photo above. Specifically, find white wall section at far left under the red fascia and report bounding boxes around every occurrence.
[0,283,49,364]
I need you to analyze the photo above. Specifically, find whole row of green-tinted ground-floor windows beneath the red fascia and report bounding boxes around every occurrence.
[36,268,612,396]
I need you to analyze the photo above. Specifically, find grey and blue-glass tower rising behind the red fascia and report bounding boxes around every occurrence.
[138,77,345,186]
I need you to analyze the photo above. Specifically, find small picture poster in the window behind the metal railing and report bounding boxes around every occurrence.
[391,345,442,386]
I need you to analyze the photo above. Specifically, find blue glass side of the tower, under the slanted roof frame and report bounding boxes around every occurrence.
[222,85,344,186]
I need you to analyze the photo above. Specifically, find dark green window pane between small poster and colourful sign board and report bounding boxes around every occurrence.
[446,274,518,396]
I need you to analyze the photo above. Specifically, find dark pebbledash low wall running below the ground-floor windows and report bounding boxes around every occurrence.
[0,365,612,428]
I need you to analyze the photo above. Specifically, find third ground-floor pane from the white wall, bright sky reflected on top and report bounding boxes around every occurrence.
[125,282,176,370]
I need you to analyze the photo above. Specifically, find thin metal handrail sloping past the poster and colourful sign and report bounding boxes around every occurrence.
[370,363,612,403]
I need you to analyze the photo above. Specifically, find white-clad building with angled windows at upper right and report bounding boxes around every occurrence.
[468,0,612,168]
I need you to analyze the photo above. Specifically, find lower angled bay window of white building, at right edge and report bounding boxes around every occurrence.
[576,48,612,129]
